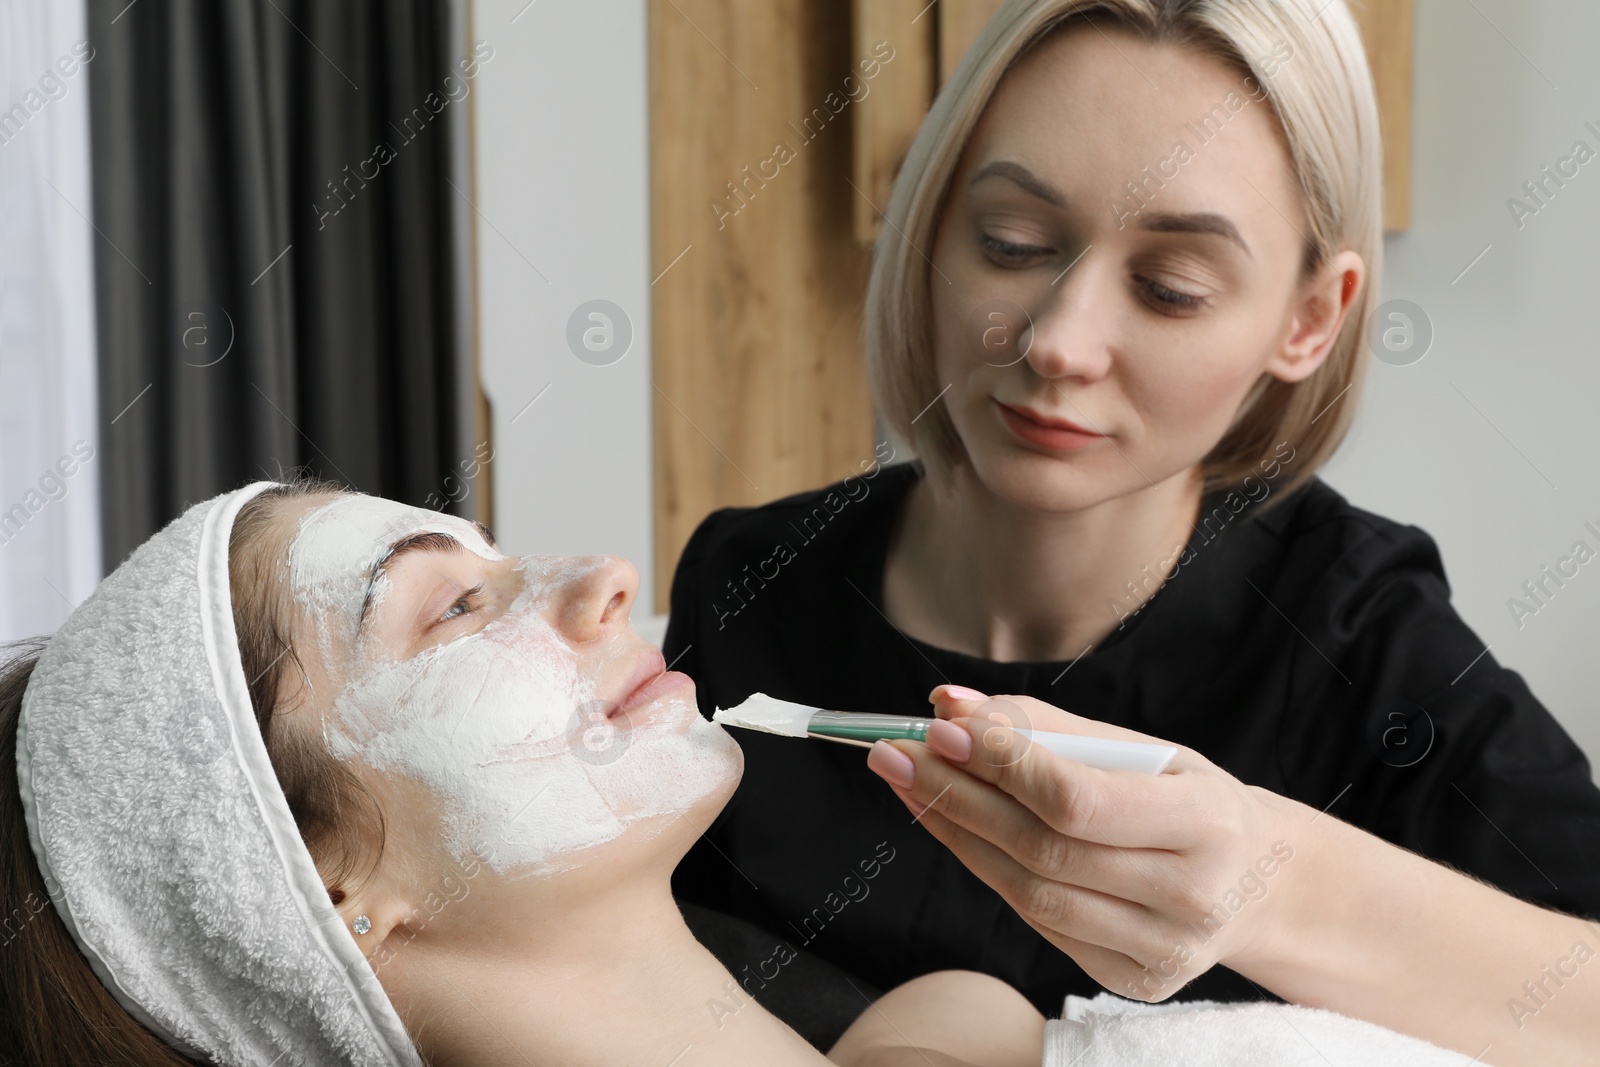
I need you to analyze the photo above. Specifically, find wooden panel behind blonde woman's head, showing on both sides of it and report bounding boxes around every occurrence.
[939,0,1414,232]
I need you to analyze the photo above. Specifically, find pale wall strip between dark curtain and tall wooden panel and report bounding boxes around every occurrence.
[470,0,656,607]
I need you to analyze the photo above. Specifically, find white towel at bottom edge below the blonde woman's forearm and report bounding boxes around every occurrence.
[1043,993,1480,1067]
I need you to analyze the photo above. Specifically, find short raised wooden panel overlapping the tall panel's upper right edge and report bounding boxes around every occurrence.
[853,0,938,245]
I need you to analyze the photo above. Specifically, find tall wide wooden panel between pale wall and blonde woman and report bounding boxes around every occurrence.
[650,0,893,611]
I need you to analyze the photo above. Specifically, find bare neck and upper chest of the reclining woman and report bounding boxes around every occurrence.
[408,872,827,1067]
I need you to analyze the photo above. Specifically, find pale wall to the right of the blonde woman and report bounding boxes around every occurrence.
[1328,0,1600,763]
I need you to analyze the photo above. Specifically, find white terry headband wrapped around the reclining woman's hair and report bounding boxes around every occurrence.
[16,482,421,1067]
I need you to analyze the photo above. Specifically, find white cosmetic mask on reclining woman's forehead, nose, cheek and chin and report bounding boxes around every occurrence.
[290,496,738,873]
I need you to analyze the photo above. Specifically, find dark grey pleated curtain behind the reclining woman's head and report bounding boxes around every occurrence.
[88,0,464,569]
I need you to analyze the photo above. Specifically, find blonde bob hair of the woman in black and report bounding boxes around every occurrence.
[864,0,1382,499]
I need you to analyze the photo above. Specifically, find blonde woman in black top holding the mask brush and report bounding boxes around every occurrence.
[666,0,1600,1064]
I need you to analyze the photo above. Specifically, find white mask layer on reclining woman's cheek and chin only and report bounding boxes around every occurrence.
[328,605,738,873]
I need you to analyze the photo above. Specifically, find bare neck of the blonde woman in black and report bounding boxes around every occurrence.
[883,466,1202,662]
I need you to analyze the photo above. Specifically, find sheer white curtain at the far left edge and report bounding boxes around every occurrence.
[0,0,101,640]
